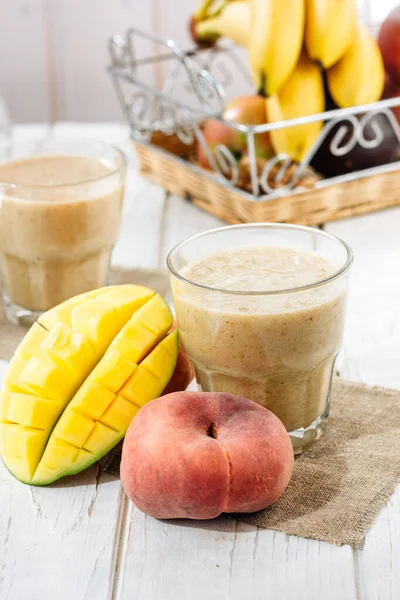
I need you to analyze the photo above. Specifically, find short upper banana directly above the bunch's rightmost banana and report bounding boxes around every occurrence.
[305,0,357,69]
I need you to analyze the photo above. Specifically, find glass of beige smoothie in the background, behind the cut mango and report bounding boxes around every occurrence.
[0,140,126,324]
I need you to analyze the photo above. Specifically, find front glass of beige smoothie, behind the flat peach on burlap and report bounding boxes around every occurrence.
[167,223,353,454]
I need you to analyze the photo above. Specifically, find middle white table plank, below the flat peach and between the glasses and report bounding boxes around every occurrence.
[117,180,357,600]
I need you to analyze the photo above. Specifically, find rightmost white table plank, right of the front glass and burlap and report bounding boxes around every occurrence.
[326,208,400,600]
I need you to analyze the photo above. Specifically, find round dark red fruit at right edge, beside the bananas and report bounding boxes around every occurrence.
[378,6,400,85]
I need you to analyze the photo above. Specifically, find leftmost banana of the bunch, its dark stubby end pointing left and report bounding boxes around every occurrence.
[193,0,250,46]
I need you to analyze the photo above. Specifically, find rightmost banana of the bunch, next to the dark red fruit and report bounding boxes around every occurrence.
[327,26,385,108]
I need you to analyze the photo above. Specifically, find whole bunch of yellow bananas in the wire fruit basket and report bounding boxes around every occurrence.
[191,0,384,161]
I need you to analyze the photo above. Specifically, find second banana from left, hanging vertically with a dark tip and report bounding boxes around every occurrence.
[248,0,305,97]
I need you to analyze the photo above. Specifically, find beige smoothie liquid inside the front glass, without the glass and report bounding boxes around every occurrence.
[172,246,345,431]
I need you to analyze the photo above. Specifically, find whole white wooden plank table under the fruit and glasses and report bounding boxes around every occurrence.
[0,124,400,600]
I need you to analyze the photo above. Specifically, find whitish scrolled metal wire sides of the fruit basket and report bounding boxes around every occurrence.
[109,29,400,201]
